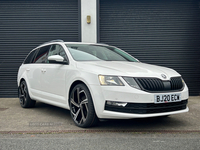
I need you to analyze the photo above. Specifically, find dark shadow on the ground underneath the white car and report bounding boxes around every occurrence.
[34,102,186,131]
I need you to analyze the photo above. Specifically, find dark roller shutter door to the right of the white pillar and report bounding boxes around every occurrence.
[99,0,200,95]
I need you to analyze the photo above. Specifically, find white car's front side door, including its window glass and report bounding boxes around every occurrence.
[41,44,69,103]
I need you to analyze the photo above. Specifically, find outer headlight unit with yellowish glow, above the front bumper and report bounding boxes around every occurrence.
[99,75,124,86]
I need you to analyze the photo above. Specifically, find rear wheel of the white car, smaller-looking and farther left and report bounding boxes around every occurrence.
[18,81,36,108]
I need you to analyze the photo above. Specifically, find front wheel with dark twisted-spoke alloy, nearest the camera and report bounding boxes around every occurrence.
[69,84,98,128]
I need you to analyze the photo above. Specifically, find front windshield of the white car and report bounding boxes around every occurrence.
[66,44,138,62]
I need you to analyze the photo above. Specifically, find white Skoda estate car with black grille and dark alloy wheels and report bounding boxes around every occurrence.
[17,40,189,127]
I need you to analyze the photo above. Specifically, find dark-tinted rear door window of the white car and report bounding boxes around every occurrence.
[34,45,50,63]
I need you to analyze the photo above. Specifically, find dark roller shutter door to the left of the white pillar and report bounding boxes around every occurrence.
[0,0,79,97]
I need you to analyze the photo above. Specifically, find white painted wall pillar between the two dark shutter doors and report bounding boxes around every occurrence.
[81,0,97,43]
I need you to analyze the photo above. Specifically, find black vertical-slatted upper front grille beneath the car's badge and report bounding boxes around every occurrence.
[135,77,183,92]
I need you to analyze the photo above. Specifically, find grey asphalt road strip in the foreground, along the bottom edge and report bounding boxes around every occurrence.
[0,132,200,150]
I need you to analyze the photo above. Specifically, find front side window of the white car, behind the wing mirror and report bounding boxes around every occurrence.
[47,44,67,62]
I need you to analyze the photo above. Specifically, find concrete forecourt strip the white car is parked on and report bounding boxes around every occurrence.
[0,96,200,134]
